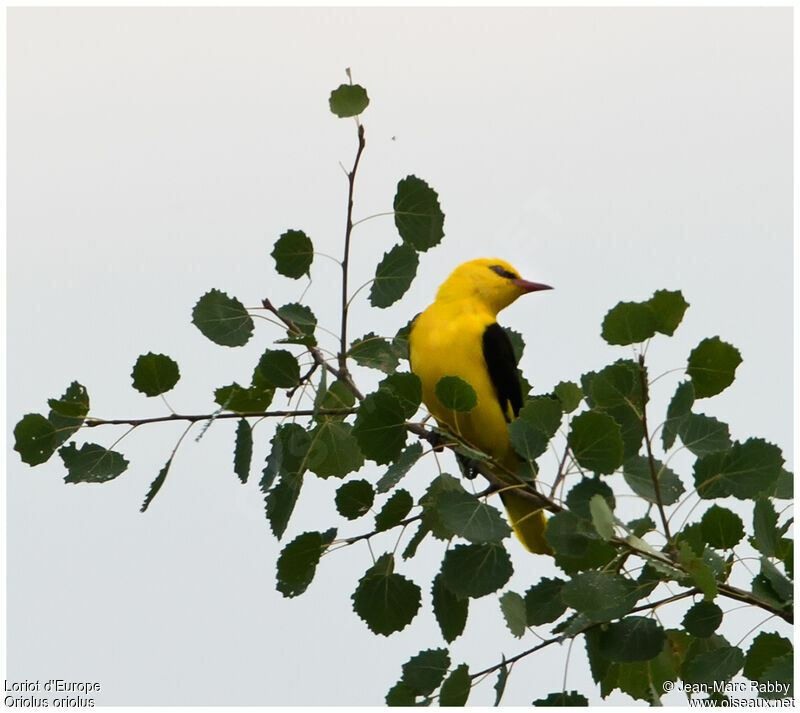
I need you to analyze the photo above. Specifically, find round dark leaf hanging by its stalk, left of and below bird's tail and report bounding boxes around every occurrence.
[352,554,421,636]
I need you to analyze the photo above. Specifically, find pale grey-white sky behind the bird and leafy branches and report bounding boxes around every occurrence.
[6,8,793,705]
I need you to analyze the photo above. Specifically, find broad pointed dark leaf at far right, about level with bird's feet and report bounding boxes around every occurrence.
[694,438,783,500]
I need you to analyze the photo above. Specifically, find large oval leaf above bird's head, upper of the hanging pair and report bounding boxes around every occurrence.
[394,176,444,252]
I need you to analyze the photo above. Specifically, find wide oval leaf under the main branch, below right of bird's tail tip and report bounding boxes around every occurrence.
[561,571,636,621]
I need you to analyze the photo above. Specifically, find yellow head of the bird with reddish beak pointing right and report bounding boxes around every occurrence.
[436,258,552,314]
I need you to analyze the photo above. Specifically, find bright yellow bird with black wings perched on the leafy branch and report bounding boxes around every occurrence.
[408,258,551,554]
